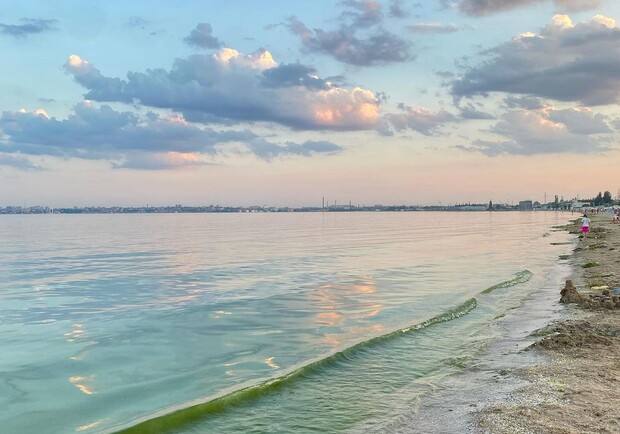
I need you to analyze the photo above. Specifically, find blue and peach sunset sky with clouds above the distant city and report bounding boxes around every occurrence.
[0,0,620,207]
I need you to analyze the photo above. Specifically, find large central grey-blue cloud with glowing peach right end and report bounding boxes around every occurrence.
[65,48,379,130]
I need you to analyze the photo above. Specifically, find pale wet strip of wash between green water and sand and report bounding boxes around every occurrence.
[394,215,577,434]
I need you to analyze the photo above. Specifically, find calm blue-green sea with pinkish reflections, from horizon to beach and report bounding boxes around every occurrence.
[0,211,575,434]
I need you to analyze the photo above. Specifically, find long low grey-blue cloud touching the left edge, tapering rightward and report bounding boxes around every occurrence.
[0,102,342,169]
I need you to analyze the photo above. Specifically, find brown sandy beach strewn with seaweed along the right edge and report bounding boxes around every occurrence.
[477,213,620,434]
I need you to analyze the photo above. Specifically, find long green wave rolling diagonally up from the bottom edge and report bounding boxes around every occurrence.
[118,298,478,434]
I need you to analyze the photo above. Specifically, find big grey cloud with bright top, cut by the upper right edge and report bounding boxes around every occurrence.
[452,15,620,106]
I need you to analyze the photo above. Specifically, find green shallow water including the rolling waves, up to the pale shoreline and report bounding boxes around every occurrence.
[119,270,544,434]
